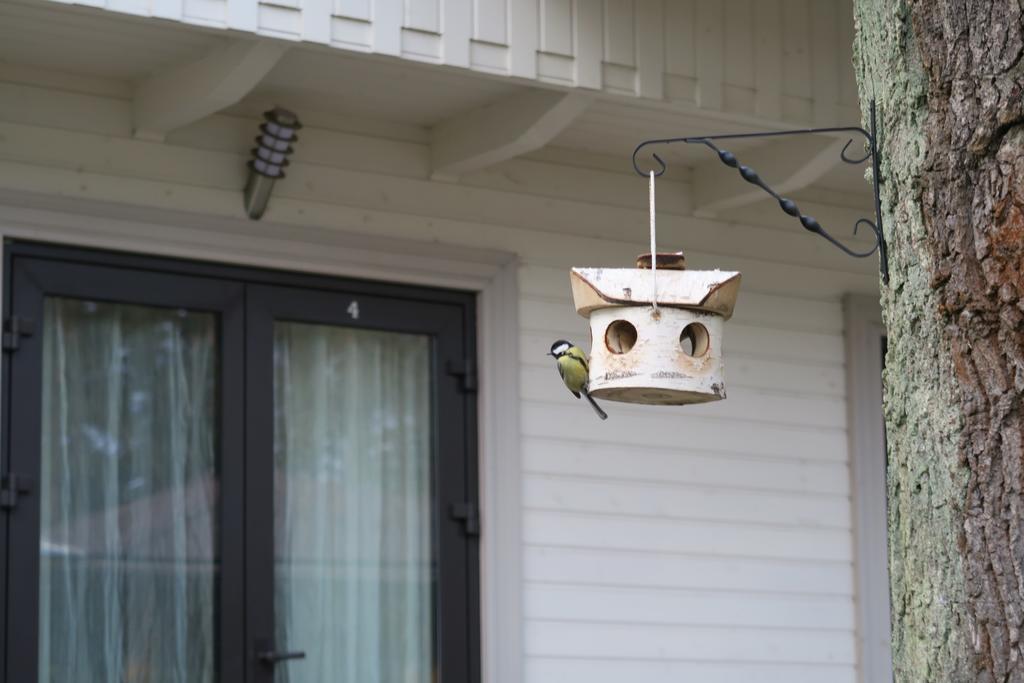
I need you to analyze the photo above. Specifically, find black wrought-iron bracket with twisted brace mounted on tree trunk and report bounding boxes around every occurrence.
[633,99,889,285]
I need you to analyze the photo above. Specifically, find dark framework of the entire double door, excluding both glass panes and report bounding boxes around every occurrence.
[0,241,480,683]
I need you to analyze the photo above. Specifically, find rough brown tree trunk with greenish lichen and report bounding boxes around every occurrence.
[854,0,1024,683]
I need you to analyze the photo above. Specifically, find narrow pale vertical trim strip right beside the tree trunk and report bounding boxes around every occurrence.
[843,295,893,683]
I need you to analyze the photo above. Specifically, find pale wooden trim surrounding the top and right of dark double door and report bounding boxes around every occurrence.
[0,190,523,683]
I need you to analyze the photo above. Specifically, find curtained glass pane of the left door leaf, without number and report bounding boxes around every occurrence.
[39,298,218,683]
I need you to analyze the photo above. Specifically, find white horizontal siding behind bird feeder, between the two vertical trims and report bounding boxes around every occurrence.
[520,282,855,683]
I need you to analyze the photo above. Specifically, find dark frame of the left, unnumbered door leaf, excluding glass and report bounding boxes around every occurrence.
[4,250,244,683]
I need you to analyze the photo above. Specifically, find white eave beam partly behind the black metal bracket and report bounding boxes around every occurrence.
[692,135,847,218]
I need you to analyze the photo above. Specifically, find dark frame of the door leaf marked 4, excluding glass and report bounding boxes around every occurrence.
[246,285,470,683]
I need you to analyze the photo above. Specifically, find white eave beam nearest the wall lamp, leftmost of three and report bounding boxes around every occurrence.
[133,40,288,140]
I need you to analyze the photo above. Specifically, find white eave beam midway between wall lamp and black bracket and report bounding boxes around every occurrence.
[431,90,594,179]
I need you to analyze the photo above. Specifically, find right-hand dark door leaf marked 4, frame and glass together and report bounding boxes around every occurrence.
[247,287,470,683]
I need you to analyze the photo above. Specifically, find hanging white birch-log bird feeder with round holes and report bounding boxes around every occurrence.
[570,253,740,405]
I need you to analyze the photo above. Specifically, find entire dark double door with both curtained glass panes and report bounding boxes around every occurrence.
[0,245,479,683]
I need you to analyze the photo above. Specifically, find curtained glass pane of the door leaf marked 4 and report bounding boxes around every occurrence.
[274,323,436,683]
